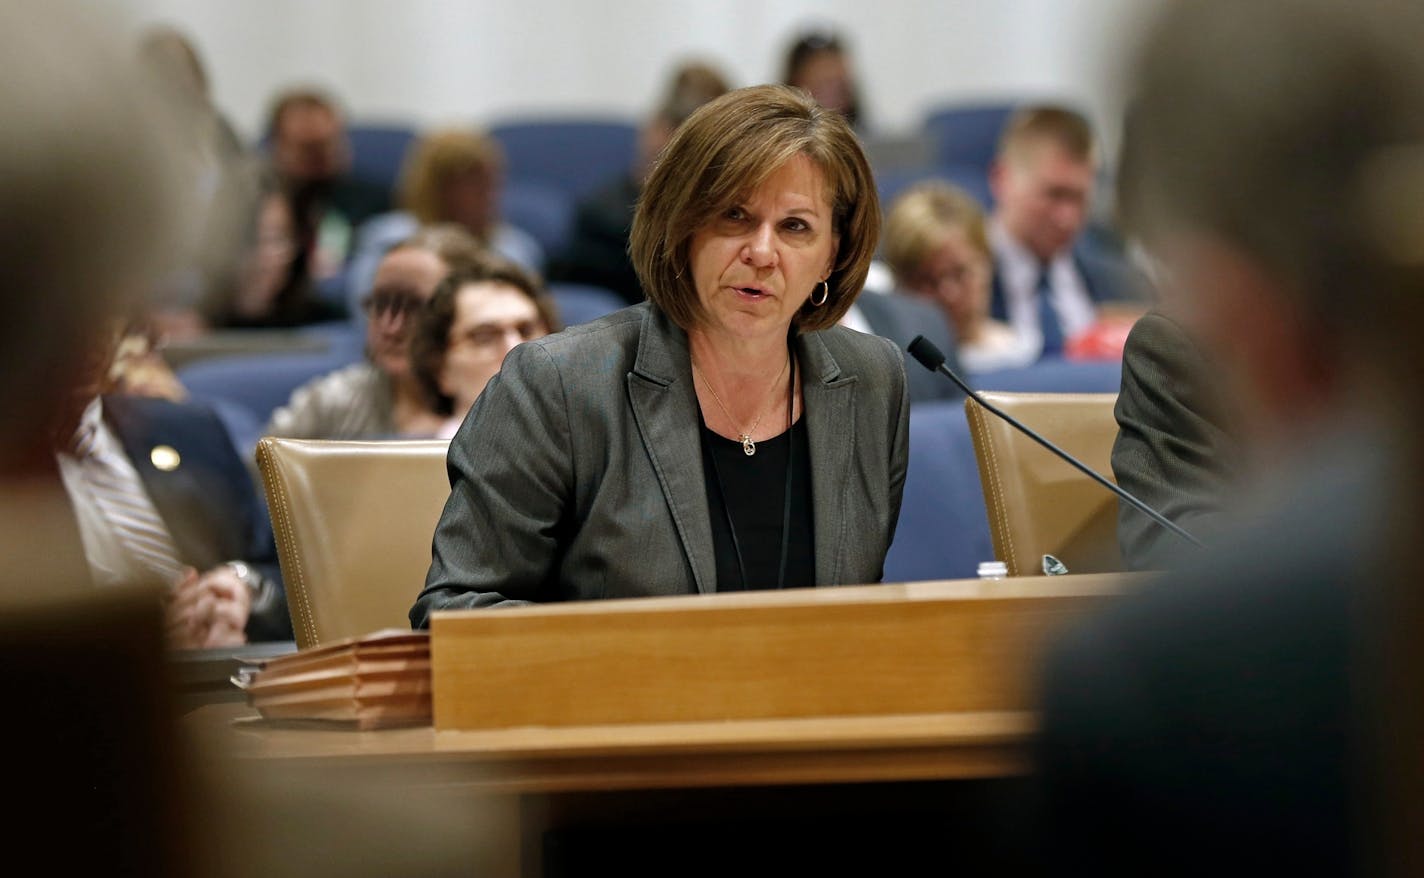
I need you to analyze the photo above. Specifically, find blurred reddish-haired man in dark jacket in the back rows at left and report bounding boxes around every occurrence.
[266,88,390,297]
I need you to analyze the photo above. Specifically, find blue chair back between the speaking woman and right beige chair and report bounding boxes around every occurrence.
[884,401,994,582]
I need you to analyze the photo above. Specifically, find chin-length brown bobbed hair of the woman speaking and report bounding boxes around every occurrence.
[629,85,880,332]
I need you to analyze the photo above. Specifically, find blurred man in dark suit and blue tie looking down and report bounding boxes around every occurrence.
[988,105,1143,357]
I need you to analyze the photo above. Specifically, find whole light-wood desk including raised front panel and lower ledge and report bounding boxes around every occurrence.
[191,573,1138,875]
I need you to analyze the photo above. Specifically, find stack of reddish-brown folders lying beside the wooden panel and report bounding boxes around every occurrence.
[232,629,431,729]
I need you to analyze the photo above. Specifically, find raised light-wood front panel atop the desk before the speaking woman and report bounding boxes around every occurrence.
[430,576,1121,731]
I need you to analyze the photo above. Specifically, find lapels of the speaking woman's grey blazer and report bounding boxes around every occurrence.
[628,305,856,593]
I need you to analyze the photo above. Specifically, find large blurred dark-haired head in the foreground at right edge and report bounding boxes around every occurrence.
[1119,0,1424,435]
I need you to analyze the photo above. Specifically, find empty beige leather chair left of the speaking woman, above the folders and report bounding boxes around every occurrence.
[258,437,450,649]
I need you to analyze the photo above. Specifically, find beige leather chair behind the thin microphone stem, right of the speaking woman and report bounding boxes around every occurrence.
[964,393,1122,576]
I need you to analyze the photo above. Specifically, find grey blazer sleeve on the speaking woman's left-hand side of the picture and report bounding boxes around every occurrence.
[410,344,572,629]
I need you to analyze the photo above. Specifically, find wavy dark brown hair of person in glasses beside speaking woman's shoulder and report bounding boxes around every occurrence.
[410,253,561,414]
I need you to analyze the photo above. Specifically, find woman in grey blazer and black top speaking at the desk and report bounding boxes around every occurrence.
[410,85,909,617]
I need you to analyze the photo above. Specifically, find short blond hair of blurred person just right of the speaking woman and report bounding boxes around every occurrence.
[884,179,993,286]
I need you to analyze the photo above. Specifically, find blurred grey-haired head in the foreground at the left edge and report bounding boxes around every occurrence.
[0,3,175,475]
